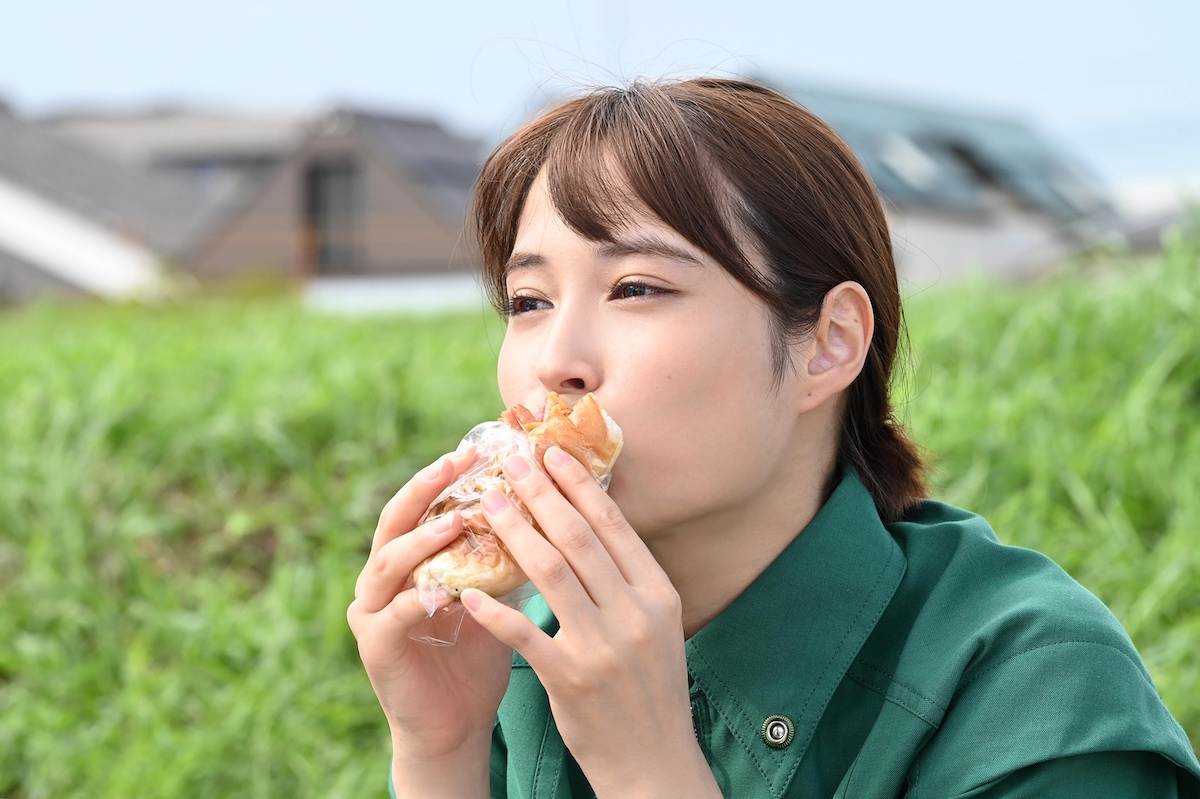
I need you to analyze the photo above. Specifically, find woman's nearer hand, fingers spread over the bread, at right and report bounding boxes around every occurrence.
[462,447,720,798]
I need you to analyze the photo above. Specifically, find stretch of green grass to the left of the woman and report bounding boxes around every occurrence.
[0,302,499,799]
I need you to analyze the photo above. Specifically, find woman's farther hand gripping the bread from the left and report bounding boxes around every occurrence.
[347,451,512,797]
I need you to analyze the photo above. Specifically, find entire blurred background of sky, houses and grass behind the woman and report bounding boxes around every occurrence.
[0,0,1200,799]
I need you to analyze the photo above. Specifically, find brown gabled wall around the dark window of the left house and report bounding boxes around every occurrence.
[188,131,473,280]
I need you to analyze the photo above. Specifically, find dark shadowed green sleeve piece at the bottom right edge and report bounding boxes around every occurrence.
[955,752,1194,799]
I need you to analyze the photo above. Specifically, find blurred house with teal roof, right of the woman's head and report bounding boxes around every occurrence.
[767,80,1118,289]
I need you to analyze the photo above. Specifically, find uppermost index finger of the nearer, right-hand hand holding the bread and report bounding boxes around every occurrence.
[544,446,666,585]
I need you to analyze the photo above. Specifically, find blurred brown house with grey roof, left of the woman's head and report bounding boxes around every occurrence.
[43,108,481,282]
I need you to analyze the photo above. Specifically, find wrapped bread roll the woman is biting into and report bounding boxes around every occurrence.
[413,394,623,614]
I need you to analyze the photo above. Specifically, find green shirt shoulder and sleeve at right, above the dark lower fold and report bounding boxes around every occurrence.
[873,503,1198,797]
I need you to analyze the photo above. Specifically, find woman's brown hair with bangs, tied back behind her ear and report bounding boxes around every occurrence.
[474,78,925,521]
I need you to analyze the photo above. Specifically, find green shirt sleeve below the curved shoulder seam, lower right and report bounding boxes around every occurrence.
[910,641,1200,799]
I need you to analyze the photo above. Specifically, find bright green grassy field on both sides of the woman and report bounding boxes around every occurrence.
[0,226,1200,799]
